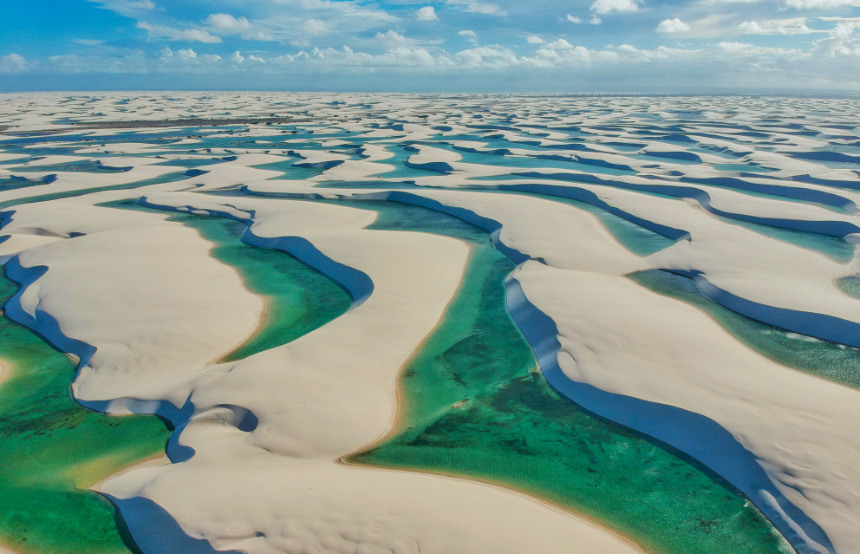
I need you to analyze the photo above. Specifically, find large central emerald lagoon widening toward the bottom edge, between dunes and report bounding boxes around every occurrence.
[342,198,791,554]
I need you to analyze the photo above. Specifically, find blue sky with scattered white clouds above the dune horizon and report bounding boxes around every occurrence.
[0,0,860,94]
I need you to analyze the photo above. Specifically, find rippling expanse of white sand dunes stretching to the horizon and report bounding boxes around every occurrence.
[0,93,860,553]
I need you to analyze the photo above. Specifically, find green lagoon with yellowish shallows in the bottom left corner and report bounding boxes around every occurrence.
[0,268,169,553]
